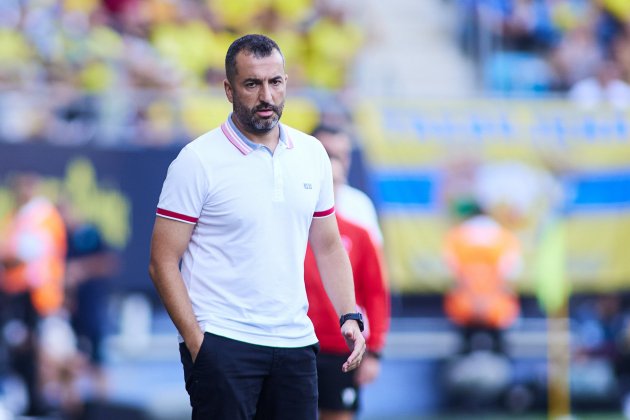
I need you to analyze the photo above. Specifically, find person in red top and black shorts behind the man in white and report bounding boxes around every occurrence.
[304,157,390,420]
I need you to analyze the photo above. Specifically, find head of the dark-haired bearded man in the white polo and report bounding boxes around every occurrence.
[223,35,287,134]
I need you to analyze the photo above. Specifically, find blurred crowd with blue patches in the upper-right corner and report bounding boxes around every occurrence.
[458,0,630,99]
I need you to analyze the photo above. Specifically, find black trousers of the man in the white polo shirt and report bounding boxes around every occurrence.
[179,333,319,420]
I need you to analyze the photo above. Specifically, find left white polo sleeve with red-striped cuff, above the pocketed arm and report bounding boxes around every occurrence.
[156,147,208,224]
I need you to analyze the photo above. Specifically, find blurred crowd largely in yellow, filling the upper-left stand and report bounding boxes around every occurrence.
[0,0,365,146]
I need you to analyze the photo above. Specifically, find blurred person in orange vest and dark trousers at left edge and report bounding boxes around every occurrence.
[0,173,66,415]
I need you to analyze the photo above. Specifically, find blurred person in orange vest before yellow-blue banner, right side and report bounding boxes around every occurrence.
[444,199,520,410]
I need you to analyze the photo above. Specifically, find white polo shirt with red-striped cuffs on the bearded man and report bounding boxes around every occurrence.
[157,117,334,347]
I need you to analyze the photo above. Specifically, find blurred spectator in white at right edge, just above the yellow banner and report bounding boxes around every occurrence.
[568,60,630,110]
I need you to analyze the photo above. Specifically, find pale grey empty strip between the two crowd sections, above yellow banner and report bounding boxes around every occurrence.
[353,0,477,98]
